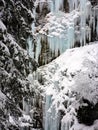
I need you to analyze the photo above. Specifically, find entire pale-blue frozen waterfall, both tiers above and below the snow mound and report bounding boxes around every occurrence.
[24,0,98,130]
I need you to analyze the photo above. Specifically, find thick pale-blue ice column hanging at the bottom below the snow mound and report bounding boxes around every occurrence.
[45,95,60,130]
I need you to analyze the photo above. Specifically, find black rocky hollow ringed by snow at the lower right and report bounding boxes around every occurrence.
[77,99,98,126]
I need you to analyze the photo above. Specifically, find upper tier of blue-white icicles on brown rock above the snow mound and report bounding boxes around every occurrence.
[28,0,98,65]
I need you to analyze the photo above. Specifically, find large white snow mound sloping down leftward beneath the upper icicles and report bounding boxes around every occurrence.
[37,42,98,103]
